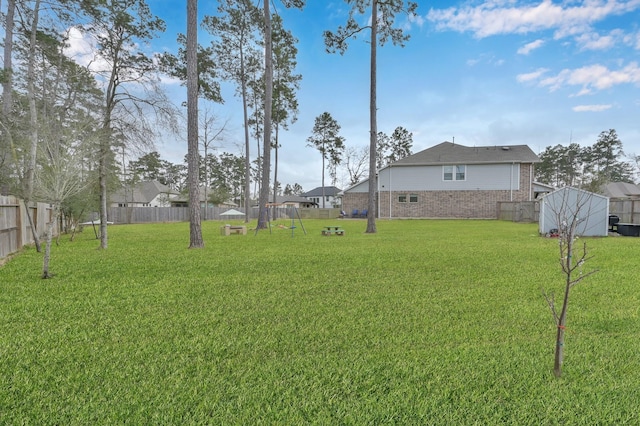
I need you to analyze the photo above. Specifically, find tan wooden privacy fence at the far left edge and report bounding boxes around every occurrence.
[0,195,53,259]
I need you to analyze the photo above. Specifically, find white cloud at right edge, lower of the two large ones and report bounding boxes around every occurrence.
[517,62,640,96]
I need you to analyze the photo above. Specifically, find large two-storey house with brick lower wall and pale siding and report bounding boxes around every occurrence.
[342,142,540,219]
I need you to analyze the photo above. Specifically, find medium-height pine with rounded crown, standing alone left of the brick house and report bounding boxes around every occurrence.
[307,112,344,208]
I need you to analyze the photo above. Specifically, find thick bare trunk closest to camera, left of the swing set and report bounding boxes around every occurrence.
[187,0,204,248]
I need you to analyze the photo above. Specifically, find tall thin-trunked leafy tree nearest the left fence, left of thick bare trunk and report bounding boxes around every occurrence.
[82,0,174,249]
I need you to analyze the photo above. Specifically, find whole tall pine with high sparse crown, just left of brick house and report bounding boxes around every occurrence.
[324,0,418,233]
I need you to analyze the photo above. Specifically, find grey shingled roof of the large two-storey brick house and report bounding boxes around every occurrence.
[391,142,540,167]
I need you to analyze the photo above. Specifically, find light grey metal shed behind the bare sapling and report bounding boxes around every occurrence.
[539,187,609,237]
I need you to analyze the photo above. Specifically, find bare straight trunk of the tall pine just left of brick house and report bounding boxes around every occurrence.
[366,0,378,234]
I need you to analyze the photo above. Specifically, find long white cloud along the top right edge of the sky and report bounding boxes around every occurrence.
[426,0,640,38]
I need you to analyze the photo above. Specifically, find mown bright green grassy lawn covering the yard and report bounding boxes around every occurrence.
[0,220,640,425]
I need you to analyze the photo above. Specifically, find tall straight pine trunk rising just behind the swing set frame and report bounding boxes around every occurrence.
[258,1,273,229]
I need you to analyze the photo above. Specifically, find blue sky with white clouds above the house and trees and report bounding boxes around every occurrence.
[149,0,640,190]
